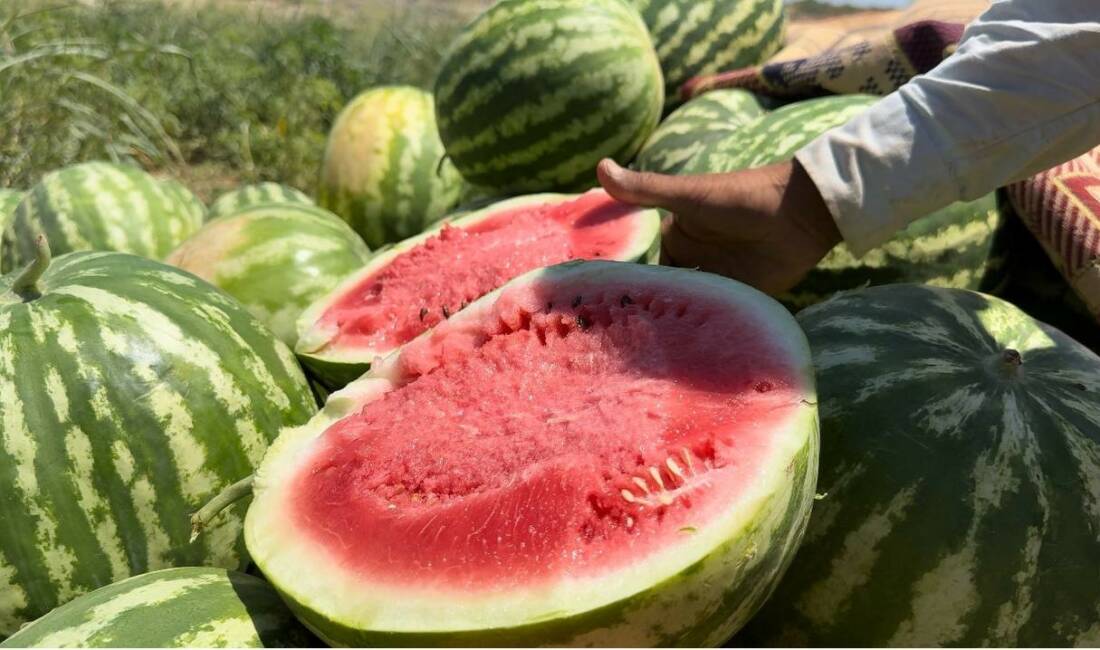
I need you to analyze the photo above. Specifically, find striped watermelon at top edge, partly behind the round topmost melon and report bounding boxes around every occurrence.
[631,0,787,107]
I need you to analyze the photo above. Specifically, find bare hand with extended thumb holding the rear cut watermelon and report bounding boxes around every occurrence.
[597,159,842,294]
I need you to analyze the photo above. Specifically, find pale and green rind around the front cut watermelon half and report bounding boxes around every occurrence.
[245,262,818,647]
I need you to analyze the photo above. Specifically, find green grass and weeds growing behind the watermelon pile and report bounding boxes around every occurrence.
[0,0,470,199]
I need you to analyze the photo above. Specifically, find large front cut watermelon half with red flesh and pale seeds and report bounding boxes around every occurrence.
[245,262,817,647]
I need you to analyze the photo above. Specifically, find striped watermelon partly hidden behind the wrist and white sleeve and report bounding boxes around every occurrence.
[684,95,1005,310]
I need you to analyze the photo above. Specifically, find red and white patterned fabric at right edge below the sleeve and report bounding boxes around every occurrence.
[1008,147,1100,321]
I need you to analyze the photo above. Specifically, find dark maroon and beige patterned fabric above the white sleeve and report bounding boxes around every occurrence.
[681,20,966,100]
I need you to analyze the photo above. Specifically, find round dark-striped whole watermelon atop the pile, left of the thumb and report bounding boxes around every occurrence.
[436,0,664,195]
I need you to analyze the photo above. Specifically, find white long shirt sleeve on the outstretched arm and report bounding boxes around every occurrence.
[795,0,1100,255]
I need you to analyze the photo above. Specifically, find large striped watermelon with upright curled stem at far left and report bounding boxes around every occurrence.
[0,244,316,636]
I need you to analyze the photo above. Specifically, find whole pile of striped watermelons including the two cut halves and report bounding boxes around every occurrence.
[0,0,1100,647]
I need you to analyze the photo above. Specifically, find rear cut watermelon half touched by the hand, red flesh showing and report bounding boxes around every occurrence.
[296,190,660,388]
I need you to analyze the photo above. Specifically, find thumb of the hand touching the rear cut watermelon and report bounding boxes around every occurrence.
[596,158,707,214]
